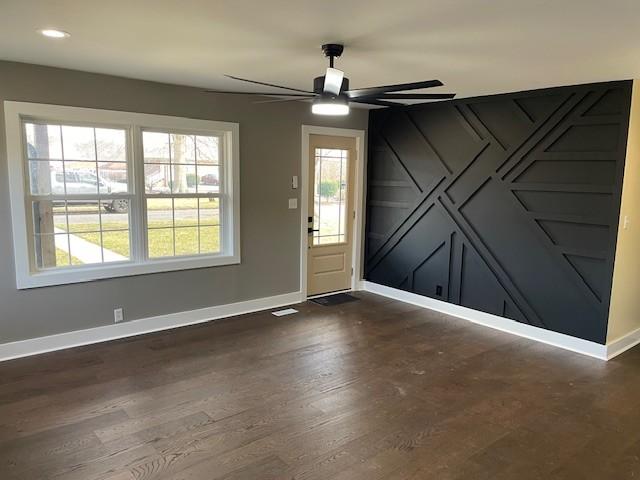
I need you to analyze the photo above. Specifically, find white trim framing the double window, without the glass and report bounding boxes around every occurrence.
[4,101,240,289]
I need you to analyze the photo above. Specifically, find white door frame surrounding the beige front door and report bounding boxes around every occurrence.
[299,125,366,301]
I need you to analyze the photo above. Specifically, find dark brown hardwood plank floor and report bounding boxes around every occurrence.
[0,293,640,480]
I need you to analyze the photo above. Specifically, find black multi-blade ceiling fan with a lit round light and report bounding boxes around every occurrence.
[206,43,455,115]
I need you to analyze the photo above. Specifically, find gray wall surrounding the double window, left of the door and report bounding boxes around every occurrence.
[0,62,368,343]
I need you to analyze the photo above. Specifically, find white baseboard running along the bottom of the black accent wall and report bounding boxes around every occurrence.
[362,281,608,360]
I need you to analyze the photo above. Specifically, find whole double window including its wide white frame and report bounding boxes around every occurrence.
[5,102,240,288]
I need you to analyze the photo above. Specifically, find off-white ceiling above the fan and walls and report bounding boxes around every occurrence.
[0,0,640,101]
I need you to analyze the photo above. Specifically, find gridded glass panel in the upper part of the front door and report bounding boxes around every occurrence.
[313,148,349,245]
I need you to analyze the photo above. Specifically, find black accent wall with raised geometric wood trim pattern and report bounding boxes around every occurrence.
[365,81,632,343]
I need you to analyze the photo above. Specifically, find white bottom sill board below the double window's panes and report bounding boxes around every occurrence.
[16,254,240,290]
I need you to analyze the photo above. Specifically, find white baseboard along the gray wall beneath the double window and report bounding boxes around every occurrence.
[0,292,302,361]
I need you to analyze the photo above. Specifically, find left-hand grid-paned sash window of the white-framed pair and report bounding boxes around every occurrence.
[22,120,133,270]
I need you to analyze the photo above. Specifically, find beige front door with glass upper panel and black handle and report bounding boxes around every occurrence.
[307,135,356,295]
